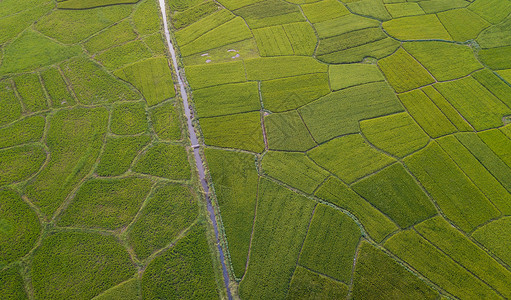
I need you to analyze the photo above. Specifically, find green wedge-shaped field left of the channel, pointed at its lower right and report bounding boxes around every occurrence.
[61,57,141,104]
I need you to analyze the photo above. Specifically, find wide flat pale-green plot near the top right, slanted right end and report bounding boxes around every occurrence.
[383,15,452,41]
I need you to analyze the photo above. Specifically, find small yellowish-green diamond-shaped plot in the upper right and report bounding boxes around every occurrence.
[378,48,435,93]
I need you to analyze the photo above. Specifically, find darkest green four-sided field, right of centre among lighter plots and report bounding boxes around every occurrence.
[353,164,437,228]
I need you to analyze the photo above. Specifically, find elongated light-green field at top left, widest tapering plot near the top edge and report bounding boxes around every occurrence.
[35,5,132,44]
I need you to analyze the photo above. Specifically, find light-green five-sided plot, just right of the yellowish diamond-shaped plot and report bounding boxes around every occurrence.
[403,41,483,81]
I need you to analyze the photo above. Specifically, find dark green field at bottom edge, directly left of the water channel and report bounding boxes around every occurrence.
[142,225,218,299]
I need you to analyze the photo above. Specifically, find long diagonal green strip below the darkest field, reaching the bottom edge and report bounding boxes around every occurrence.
[385,230,499,299]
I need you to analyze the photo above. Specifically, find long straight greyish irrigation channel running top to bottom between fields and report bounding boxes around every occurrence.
[159,0,232,300]
